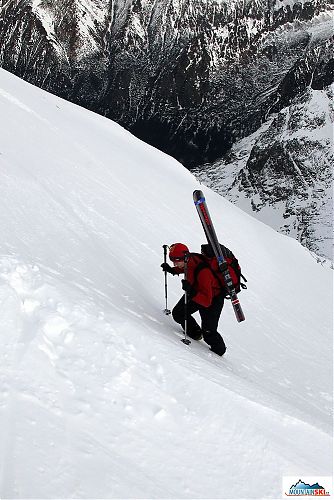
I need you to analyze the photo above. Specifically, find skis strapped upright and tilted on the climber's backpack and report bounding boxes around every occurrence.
[193,190,245,323]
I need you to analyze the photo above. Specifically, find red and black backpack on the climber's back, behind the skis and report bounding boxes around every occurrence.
[194,244,247,295]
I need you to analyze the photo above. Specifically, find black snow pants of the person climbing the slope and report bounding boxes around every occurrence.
[172,294,226,356]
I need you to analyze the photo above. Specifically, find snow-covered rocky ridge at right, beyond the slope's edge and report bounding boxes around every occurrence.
[194,86,334,260]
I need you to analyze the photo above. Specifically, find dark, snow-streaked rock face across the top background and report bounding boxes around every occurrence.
[0,0,333,168]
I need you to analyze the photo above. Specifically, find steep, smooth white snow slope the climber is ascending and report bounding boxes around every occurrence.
[0,70,332,499]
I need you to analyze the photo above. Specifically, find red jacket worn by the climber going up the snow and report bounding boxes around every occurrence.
[174,255,222,307]
